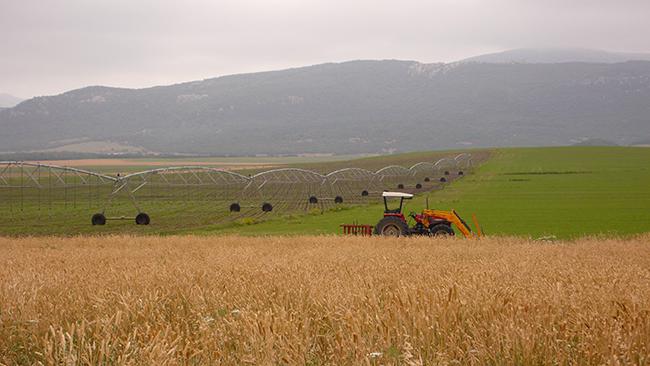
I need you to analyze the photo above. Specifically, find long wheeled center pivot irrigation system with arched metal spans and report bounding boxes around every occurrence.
[0,153,472,225]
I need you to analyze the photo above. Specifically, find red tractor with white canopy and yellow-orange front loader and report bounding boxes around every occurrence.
[374,192,480,238]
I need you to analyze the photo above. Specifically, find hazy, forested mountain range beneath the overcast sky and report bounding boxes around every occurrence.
[0,49,650,155]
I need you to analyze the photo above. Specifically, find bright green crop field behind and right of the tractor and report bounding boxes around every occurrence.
[211,147,650,238]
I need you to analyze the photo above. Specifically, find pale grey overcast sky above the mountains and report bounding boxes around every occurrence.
[0,0,650,98]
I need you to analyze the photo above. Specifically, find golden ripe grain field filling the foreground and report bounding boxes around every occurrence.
[0,236,650,365]
